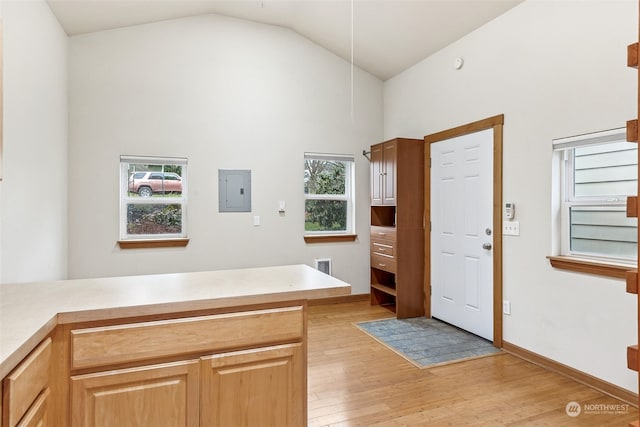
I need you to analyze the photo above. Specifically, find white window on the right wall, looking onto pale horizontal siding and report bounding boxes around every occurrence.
[553,129,638,263]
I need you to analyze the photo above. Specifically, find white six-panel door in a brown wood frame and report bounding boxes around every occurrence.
[431,129,500,341]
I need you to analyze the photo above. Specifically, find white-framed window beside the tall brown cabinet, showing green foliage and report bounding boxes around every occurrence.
[304,153,354,235]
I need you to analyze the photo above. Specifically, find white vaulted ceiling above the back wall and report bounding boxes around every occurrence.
[48,0,524,80]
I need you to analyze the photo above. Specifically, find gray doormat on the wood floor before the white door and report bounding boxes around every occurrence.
[356,317,502,368]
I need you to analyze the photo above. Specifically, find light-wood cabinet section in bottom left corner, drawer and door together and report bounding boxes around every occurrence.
[2,338,53,427]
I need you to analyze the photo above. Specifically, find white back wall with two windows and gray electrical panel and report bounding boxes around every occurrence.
[69,15,383,293]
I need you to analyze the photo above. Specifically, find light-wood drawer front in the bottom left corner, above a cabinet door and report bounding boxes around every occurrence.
[2,338,51,427]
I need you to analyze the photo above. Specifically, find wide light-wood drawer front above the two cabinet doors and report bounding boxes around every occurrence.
[71,306,304,369]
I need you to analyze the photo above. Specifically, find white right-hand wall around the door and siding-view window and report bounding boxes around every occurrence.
[384,0,638,391]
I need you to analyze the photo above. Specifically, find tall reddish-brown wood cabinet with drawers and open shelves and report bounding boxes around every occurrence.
[370,138,425,318]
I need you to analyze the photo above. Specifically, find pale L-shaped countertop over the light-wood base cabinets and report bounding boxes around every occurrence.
[0,265,351,378]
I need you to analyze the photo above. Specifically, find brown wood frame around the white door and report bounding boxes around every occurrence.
[424,114,504,348]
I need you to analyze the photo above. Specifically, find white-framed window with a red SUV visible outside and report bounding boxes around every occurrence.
[120,156,187,241]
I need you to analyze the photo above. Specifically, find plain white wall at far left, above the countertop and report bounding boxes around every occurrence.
[0,1,67,282]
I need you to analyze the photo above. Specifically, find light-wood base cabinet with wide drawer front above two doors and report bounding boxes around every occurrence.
[69,305,307,427]
